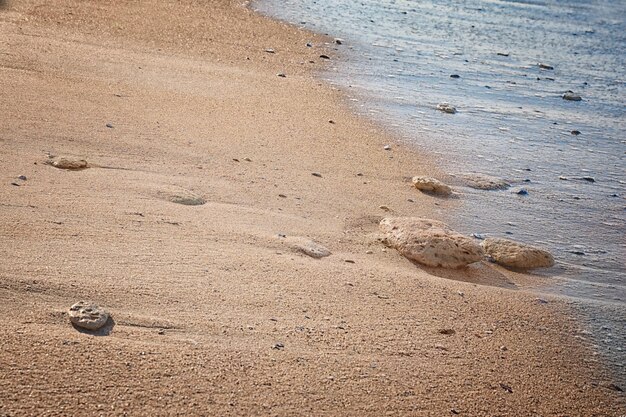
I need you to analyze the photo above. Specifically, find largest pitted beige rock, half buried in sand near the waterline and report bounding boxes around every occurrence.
[380,217,483,268]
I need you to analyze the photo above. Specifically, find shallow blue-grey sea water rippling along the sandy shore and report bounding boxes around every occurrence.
[253,0,626,373]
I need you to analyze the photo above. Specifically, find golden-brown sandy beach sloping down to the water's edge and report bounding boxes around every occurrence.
[0,0,626,417]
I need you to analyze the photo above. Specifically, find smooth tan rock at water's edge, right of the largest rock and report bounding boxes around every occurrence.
[482,238,554,269]
